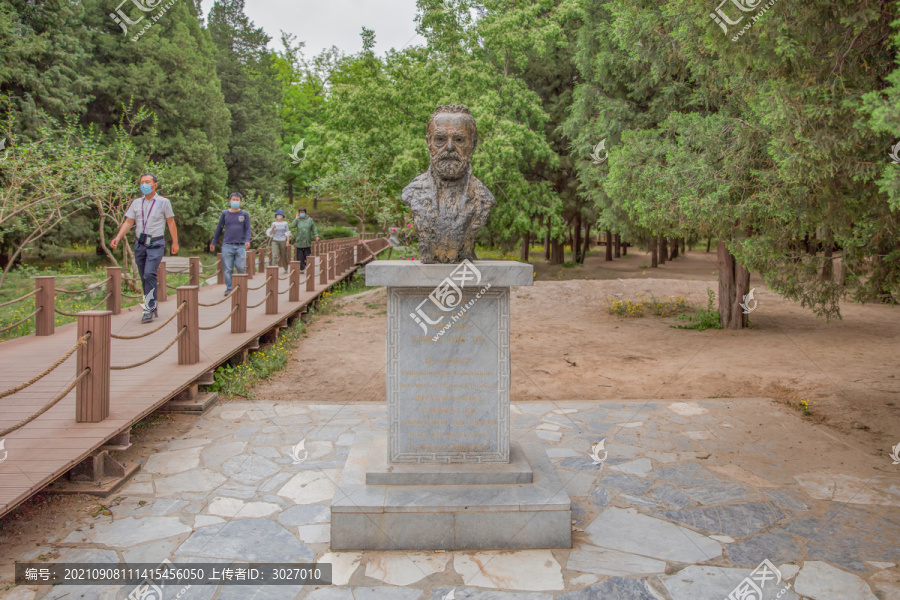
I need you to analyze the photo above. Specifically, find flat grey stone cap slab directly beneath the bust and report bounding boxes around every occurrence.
[366,260,534,289]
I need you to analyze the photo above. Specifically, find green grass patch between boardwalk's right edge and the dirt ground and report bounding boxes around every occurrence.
[209,319,306,398]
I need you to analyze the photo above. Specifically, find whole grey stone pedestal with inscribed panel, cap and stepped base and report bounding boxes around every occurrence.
[331,261,572,550]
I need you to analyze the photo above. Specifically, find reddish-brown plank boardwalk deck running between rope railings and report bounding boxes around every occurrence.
[0,239,386,517]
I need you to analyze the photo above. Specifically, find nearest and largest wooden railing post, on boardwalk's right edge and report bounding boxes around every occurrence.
[75,310,112,423]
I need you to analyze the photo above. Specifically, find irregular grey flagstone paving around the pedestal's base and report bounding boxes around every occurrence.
[0,399,900,600]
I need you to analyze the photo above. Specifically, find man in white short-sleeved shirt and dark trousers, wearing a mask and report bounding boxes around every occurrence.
[109,173,178,323]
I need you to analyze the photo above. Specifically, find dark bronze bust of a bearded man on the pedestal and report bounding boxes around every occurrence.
[401,104,497,263]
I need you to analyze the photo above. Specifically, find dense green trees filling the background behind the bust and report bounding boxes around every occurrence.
[0,0,900,328]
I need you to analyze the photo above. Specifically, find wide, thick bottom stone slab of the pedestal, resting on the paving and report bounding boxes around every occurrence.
[331,437,572,551]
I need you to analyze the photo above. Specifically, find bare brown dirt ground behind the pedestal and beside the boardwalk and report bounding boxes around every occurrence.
[0,249,900,590]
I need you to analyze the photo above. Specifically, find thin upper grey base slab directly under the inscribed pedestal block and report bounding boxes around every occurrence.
[366,435,534,485]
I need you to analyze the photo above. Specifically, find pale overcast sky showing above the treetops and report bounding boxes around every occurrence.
[202,0,424,57]
